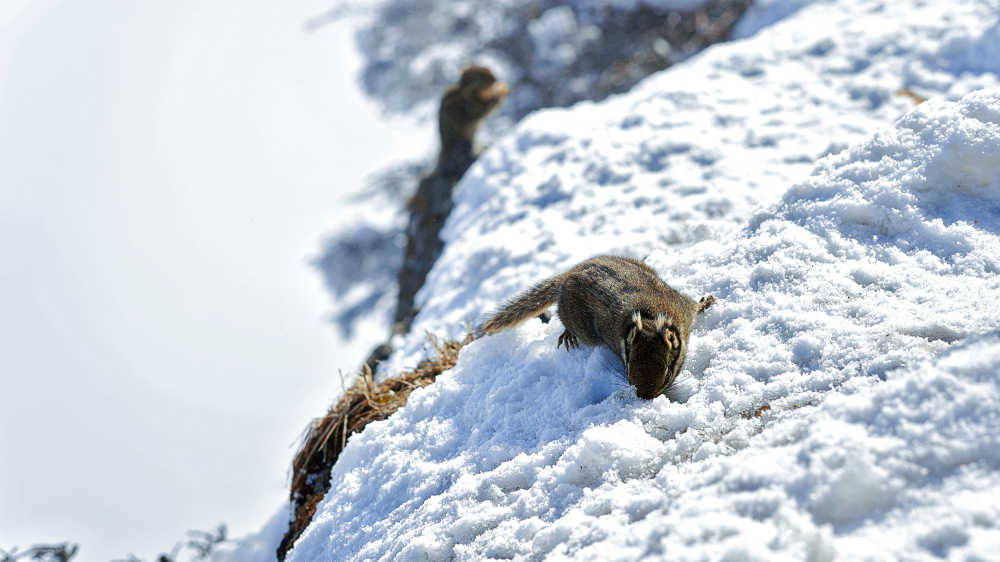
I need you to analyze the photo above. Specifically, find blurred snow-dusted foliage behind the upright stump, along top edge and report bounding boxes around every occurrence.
[304,0,750,123]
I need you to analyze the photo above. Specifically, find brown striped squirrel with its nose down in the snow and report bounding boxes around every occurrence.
[476,256,715,399]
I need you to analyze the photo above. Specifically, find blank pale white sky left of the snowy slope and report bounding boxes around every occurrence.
[0,0,426,560]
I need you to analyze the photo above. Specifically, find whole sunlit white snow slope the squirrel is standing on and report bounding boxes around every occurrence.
[289,1,1000,561]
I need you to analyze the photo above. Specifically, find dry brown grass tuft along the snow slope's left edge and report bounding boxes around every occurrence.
[278,334,470,560]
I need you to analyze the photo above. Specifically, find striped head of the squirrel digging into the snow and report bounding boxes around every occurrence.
[619,311,686,399]
